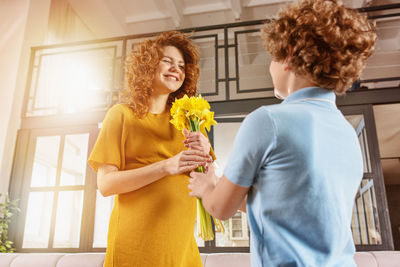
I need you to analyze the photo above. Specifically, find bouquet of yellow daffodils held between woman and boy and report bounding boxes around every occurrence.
[170,95,225,241]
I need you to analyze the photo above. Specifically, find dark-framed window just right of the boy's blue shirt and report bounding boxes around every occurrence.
[340,105,394,250]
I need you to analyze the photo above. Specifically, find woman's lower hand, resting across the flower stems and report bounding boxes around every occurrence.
[165,149,212,175]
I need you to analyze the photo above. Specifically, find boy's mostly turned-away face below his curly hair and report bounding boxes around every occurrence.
[269,60,289,99]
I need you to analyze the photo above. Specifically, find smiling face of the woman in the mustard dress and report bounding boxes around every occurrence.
[153,46,185,94]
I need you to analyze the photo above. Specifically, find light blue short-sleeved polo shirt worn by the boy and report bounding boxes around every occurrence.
[224,87,363,267]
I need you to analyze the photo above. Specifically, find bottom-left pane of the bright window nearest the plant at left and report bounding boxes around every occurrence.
[22,192,53,248]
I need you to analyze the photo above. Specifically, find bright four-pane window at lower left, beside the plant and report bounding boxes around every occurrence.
[10,127,96,252]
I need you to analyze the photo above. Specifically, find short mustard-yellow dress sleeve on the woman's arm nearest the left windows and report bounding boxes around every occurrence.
[88,104,125,172]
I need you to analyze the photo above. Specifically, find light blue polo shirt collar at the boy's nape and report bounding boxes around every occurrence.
[282,87,336,106]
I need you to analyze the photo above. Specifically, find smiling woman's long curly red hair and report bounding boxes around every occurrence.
[125,31,200,118]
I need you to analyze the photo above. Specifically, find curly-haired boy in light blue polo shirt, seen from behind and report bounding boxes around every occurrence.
[189,0,376,267]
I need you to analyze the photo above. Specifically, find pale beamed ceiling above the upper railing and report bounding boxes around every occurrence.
[68,0,398,38]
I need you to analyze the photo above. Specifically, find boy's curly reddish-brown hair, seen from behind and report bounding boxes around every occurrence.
[261,0,376,95]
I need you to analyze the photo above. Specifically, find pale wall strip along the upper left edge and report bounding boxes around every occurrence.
[0,0,51,197]
